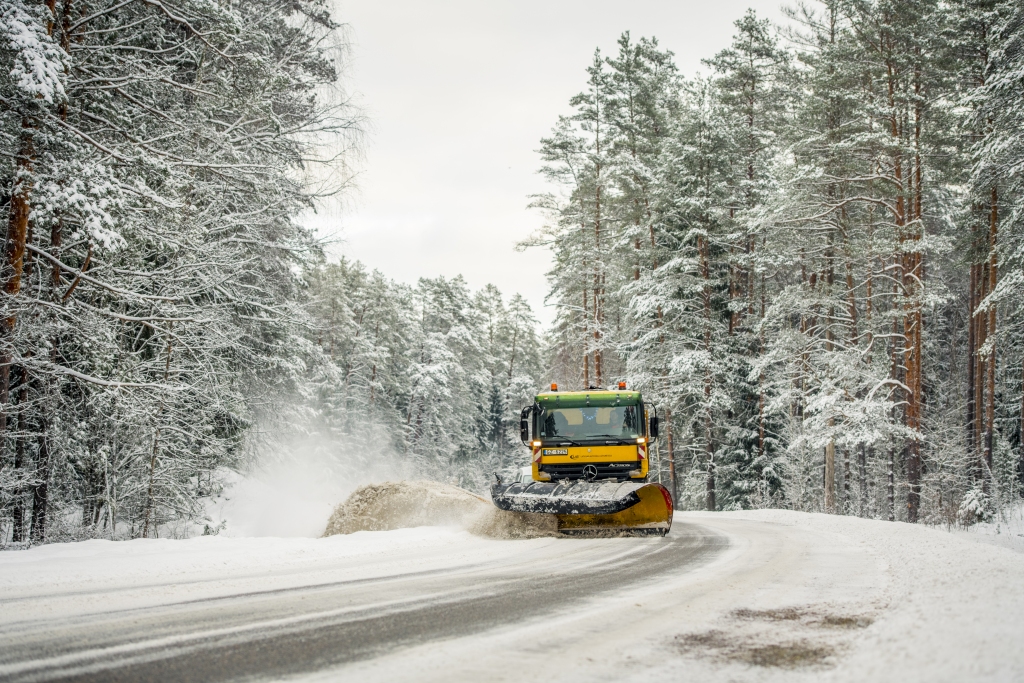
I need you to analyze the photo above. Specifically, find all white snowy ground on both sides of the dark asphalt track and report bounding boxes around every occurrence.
[0,510,1024,683]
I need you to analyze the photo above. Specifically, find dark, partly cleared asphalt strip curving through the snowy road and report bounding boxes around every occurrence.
[0,523,727,683]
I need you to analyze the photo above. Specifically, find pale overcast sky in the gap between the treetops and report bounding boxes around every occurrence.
[309,0,781,324]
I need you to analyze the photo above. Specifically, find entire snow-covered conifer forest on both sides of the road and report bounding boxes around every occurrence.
[0,0,1024,545]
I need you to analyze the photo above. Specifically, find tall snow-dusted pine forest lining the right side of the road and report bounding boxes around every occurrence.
[524,0,1024,524]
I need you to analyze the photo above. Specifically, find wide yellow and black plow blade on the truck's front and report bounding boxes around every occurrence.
[490,480,672,536]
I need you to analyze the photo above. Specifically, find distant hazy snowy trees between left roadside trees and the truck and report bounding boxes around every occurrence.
[296,259,542,494]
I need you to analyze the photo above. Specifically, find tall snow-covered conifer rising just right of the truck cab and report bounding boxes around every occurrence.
[629,80,739,510]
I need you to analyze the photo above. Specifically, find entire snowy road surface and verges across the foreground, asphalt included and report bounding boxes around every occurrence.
[0,511,1024,683]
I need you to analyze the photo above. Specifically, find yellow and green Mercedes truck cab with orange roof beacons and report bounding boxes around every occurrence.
[519,383,657,482]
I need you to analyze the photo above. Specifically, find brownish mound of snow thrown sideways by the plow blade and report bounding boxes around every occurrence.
[324,481,558,539]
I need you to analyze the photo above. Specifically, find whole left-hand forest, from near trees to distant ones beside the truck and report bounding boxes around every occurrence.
[0,0,540,546]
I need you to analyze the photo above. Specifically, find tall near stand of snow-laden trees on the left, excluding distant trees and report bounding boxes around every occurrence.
[0,0,357,541]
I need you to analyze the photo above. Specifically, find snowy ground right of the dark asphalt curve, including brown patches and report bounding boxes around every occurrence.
[318,510,1024,683]
